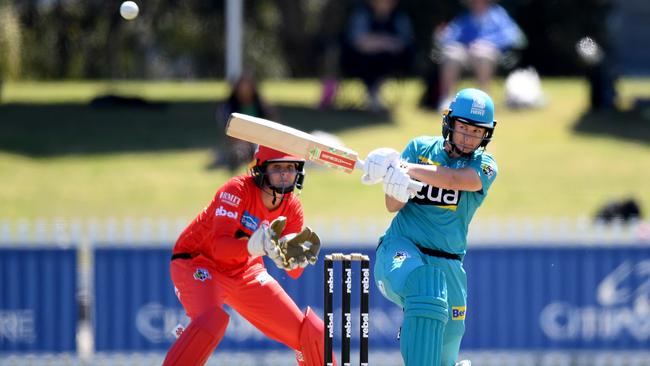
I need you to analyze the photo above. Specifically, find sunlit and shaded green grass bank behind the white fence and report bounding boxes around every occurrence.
[0,79,650,220]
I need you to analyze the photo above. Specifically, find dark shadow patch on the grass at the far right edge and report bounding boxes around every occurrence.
[573,106,650,144]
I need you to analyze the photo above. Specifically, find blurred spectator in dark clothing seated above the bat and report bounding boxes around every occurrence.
[321,0,413,111]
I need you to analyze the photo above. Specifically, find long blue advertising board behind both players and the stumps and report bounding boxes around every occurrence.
[94,245,650,351]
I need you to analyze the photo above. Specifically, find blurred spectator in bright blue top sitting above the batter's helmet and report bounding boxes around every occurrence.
[434,0,526,106]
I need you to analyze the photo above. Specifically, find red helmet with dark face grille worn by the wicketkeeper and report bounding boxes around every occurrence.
[251,145,305,194]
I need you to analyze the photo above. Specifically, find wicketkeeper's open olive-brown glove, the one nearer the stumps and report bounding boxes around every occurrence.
[279,227,320,269]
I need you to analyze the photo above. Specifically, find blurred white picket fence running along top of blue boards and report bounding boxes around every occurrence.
[0,218,650,247]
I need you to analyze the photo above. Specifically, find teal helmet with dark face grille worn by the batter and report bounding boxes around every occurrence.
[442,88,497,155]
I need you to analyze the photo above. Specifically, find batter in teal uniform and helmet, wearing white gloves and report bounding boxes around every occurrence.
[362,89,498,366]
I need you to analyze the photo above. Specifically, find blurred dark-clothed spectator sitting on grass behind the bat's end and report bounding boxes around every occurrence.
[209,72,275,172]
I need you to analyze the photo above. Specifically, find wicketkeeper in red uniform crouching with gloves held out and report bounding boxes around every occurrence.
[164,146,334,366]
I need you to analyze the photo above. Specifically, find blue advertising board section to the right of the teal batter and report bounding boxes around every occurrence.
[463,245,650,350]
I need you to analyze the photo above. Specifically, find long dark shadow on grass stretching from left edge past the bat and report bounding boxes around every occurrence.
[0,100,391,157]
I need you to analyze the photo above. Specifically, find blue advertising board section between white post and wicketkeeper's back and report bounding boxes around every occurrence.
[93,246,186,351]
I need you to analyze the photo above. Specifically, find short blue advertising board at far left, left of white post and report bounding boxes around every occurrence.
[0,246,78,352]
